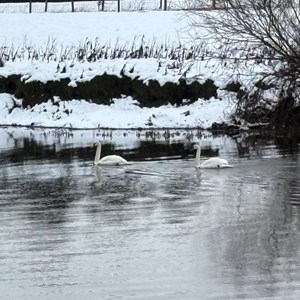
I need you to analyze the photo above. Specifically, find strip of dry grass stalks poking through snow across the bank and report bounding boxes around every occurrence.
[0,36,272,65]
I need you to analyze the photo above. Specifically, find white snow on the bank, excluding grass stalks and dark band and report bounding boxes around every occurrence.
[0,5,268,129]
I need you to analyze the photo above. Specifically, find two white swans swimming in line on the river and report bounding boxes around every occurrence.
[94,142,232,169]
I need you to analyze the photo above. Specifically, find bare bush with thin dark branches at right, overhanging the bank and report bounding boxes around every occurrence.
[188,0,300,126]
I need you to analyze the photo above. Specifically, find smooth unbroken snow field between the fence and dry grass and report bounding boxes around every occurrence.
[0,11,186,48]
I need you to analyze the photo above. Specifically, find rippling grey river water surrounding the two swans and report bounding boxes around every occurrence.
[0,129,300,300]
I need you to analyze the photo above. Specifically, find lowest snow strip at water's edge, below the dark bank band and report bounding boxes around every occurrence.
[0,94,234,129]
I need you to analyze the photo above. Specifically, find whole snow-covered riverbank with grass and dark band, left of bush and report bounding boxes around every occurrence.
[0,11,282,130]
